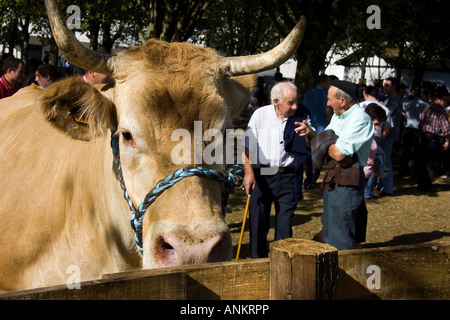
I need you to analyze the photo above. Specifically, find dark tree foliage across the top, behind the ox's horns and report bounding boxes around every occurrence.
[0,0,450,90]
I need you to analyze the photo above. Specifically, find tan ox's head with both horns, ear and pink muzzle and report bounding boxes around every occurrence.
[41,0,305,268]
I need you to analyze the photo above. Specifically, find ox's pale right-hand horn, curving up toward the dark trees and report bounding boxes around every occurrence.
[222,16,306,76]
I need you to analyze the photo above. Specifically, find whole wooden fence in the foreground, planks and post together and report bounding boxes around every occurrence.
[0,239,450,300]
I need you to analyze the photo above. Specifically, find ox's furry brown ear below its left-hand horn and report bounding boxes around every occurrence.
[39,77,117,141]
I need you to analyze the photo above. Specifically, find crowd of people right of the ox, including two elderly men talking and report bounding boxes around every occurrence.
[243,75,450,252]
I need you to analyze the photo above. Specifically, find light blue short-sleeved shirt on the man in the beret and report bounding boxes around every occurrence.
[325,104,374,166]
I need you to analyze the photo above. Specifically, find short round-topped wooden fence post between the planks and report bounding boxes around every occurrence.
[270,239,338,300]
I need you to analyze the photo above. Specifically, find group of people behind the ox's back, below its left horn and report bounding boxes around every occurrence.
[0,54,110,99]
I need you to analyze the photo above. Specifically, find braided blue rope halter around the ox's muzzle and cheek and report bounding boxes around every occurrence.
[111,132,244,253]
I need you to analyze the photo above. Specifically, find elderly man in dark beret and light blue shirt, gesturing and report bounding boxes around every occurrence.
[304,80,374,250]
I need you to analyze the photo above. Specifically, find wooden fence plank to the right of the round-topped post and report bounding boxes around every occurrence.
[338,242,450,300]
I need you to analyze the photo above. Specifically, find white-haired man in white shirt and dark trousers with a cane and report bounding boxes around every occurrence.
[242,82,311,258]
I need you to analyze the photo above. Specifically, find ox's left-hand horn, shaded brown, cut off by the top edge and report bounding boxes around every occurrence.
[45,0,112,75]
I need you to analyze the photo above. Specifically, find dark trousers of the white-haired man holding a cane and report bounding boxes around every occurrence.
[249,169,298,259]
